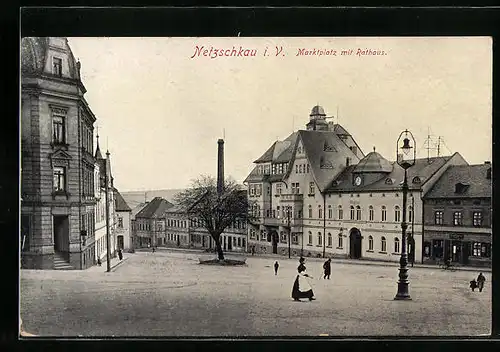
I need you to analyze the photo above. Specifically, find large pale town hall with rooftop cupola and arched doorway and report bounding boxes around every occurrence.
[245,106,466,262]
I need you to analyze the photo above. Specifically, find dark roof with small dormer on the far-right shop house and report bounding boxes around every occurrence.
[425,164,492,198]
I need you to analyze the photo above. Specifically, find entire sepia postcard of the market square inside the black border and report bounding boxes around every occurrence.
[19,37,493,338]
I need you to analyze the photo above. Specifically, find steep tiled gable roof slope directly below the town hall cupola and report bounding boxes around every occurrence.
[299,130,362,192]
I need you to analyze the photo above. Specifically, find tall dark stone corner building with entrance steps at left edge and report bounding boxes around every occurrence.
[21,37,96,269]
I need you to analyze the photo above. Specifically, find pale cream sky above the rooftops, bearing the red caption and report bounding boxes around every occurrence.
[68,37,492,191]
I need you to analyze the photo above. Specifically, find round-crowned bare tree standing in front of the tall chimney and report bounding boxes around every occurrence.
[175,176,251,260]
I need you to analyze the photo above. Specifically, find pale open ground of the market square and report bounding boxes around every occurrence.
[20,250,491,337]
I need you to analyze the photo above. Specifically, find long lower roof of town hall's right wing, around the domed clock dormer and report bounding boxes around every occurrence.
[327,156,451,192]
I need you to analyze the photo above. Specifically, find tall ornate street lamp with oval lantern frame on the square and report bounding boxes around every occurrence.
[394,130,416,300]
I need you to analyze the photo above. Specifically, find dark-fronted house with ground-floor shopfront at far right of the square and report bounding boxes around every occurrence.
[423,162,492,266]
